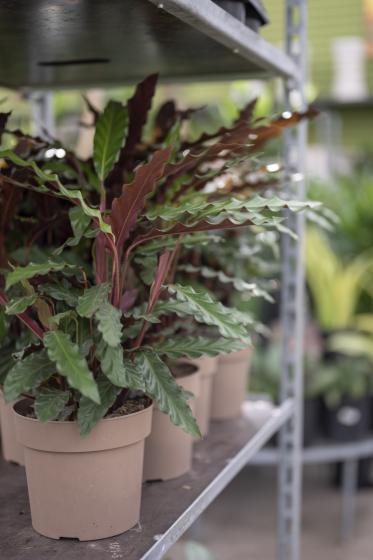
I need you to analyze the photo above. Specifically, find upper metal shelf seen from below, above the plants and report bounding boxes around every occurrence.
[0,0,296,89]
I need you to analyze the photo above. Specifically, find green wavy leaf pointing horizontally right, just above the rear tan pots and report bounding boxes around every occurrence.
[153,335,248,360]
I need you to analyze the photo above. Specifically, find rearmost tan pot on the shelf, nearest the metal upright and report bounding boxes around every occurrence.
[211,348,251,420]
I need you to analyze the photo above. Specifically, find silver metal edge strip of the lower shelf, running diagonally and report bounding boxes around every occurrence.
[141,399,294,560]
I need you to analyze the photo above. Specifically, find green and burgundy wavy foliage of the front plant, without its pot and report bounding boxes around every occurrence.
[0,73,316,435]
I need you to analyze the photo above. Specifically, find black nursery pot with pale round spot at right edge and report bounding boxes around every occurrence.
[325,397,372,443]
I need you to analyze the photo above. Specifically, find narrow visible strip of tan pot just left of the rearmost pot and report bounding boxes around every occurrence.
[192,356,218,436]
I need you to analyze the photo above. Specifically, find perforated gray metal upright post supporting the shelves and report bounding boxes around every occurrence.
[277,0,307,560]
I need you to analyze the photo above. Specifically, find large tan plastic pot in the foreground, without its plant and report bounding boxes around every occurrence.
[15,401,153,541]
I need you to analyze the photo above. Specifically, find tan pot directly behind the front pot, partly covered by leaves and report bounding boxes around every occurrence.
[144,367,200,480]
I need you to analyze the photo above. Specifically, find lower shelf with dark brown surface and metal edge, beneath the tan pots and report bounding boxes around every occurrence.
[0,400,294,560]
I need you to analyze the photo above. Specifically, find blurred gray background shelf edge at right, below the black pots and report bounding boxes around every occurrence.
[252,434,373,465]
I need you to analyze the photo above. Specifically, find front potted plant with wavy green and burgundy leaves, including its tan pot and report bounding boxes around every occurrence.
[0,77,318,540]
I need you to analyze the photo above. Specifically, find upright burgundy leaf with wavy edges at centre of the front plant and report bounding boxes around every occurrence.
[110,148,171,250]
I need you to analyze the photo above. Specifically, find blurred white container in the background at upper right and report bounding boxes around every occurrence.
[332,37,368,101]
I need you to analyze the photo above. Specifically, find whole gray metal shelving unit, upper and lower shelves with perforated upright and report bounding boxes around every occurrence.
[0,0,306,560]
